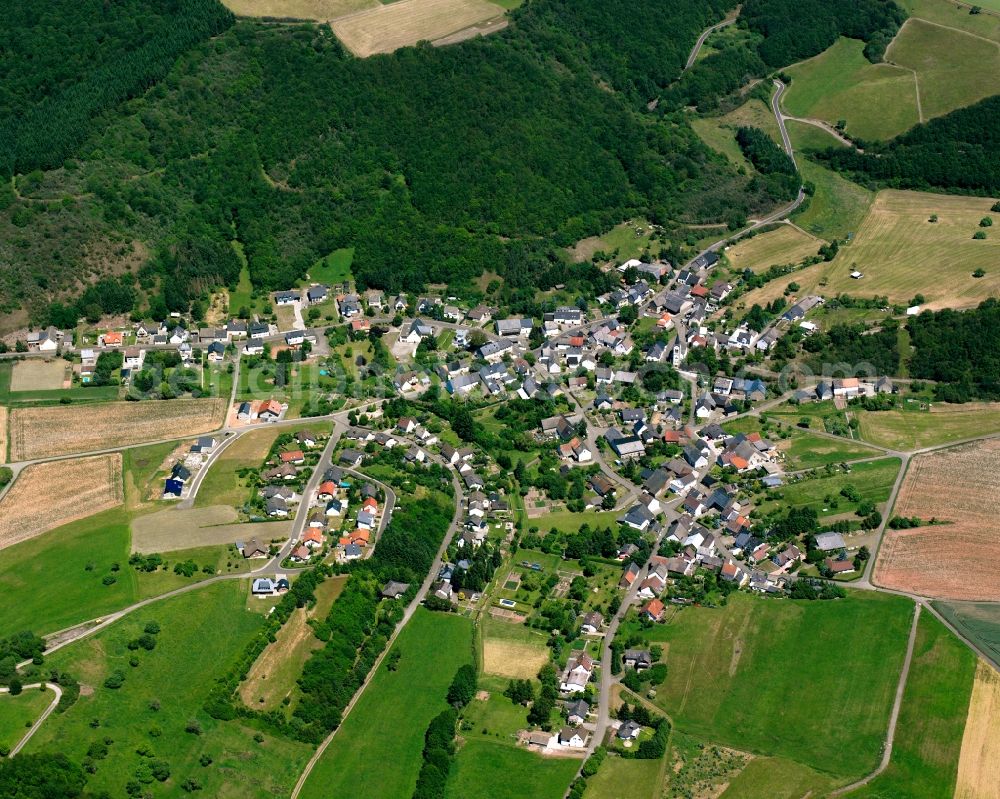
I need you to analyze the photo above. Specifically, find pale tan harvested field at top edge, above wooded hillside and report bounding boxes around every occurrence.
[331,0,504,57]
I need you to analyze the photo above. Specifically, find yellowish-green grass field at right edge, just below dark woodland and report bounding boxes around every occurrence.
[858,402,1000,451]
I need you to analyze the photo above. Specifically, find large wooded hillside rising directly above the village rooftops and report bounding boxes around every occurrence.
[0,0,792,318]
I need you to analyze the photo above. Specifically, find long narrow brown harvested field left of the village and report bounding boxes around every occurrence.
[10,398,225,461]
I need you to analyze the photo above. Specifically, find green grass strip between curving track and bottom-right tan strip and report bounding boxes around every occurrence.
[848,613,976,799]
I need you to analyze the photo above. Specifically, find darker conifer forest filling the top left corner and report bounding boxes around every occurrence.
[0,0,233,176]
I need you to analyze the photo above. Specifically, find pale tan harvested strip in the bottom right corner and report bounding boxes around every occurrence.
[955,661,1000,799]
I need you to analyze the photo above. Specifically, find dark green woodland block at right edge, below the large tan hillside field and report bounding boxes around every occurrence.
[908,298,1000,402]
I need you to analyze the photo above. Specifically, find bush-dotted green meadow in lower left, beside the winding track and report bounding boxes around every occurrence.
[29,580,310,799]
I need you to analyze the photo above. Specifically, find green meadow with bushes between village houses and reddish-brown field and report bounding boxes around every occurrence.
[760,458,900,519]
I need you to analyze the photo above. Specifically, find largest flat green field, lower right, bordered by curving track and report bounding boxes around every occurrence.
[655,593,913,782]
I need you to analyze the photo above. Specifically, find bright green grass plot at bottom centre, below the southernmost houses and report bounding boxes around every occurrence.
[446,740,580,799]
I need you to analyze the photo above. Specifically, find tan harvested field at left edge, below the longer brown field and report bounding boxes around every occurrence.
[0,452,124,549]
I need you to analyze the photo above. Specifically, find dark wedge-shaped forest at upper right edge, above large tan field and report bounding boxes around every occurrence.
[815,95,1000,195]
